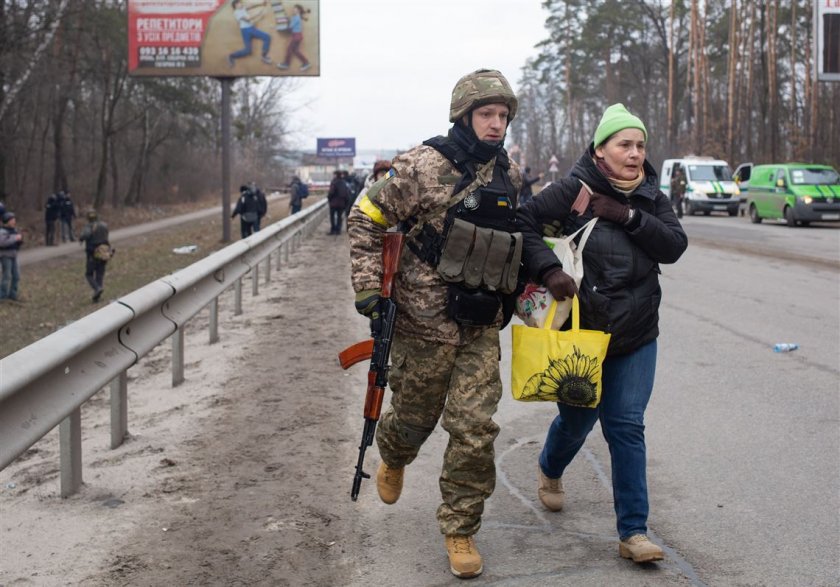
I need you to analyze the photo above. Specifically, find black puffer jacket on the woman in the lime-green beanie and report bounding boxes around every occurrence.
[518,146,688,355]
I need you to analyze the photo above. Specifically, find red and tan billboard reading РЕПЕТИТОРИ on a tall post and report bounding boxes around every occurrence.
[128,0,321,77]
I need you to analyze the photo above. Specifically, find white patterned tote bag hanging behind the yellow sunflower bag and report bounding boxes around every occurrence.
[516,218,598,330]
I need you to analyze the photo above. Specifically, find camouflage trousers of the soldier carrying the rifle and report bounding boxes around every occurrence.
[376,328,502,536]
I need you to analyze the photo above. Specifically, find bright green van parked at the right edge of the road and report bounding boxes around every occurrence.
[739,163,840,226]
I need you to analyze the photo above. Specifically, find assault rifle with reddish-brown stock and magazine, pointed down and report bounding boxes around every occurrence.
[338,232,405,501]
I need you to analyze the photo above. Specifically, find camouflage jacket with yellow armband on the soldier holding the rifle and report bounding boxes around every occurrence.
[347,145,522,345]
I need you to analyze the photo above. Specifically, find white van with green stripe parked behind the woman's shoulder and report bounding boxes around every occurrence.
[659,156,741,216]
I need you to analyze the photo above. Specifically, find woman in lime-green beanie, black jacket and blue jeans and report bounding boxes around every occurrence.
[519,104,688,563]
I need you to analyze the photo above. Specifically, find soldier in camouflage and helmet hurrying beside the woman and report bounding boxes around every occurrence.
[348,69,522,578]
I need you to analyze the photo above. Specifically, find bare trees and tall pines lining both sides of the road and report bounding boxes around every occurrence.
[0,0,840,218]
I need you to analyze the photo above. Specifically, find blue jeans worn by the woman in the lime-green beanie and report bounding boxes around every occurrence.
[540,340,656,540]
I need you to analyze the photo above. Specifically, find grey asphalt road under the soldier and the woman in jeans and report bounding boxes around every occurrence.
[348,216,840,586]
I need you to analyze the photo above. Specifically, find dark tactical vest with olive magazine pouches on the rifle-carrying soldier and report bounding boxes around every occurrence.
[408,136,522,294]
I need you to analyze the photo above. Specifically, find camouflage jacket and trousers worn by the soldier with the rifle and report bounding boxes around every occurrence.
[347,70,522,536]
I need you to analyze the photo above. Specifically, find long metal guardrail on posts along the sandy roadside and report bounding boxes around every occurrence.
[0,199,327,497]
